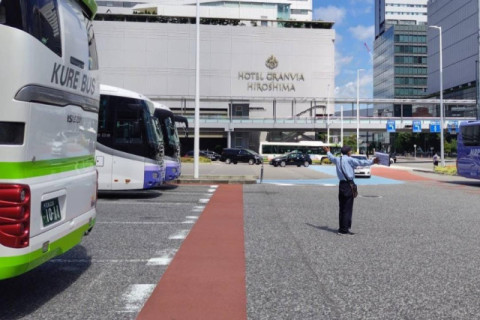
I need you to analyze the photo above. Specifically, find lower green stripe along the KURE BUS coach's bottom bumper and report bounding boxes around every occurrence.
[0,221,95,280]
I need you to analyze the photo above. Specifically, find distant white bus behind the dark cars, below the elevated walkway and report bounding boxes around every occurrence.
[258,141,340,162]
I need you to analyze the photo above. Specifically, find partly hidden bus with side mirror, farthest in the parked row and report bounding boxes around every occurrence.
[154,102,188,181]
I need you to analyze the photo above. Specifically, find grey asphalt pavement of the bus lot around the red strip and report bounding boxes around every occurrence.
[0,162,480,320]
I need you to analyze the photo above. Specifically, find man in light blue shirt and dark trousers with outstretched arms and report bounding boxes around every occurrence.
[323,146,379,235]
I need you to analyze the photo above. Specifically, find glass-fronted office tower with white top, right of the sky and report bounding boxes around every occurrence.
[373,0,429,117]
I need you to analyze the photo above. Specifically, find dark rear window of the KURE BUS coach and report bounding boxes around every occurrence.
[0,0,62,56]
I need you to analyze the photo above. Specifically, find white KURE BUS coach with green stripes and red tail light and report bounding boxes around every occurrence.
[0,0,99,279]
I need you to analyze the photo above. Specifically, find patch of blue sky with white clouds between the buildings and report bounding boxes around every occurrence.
[313,0,375,98]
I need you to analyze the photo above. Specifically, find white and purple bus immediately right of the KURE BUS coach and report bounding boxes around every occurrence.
[95,85,165,190]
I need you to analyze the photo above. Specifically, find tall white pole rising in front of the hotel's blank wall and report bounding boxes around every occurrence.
[193,0,200,179]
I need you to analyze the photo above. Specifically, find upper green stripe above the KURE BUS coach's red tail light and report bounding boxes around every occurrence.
[0,155,95,179]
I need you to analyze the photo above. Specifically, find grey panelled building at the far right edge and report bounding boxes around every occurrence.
[427,0,479,117]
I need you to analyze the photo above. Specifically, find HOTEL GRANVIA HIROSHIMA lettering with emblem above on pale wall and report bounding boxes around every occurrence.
[237,55,305,92]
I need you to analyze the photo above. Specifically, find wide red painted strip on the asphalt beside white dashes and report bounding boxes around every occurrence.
[137,185,247,320]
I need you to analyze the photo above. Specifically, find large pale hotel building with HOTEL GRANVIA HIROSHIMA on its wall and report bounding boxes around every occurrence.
[94,2,335,151]
